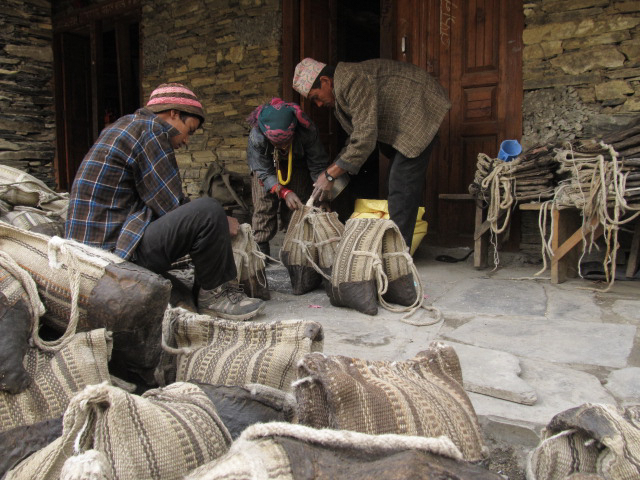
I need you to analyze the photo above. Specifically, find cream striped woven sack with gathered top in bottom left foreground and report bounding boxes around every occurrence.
[7,383,231,480]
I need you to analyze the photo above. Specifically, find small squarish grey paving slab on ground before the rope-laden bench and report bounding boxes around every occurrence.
[545,285,602,322]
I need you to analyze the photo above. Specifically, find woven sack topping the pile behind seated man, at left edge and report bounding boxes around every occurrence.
[0,165,69,217]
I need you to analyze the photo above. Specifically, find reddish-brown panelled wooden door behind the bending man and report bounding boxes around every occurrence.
[393,0,524,245]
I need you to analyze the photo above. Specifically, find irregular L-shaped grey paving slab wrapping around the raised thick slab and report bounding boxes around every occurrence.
[469,360,616,433]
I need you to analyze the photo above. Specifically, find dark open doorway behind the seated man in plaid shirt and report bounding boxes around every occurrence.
[53,2,141,190]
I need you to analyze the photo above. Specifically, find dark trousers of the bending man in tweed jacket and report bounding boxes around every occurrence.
[381,141,434,248]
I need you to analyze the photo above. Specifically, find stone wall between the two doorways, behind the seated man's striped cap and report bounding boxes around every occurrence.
[142,0,282,196]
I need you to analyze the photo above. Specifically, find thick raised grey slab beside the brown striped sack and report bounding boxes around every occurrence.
[445,342,537,405]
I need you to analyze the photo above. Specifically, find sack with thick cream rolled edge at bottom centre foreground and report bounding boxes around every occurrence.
[186,423,501,480]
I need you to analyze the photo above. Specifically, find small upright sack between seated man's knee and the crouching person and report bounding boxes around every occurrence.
[231,223,271,300]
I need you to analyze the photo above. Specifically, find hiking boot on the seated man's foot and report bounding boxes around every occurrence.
[198,281,265,321]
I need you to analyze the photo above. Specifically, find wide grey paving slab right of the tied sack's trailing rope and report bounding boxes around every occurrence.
[435,278,547,316]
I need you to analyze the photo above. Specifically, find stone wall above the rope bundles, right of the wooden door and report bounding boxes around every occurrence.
[523,0,640,147]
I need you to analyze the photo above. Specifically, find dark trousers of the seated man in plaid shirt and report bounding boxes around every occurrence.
[133,197,237,290]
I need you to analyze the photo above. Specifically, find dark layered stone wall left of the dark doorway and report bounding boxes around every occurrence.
[0,0,55,187]
